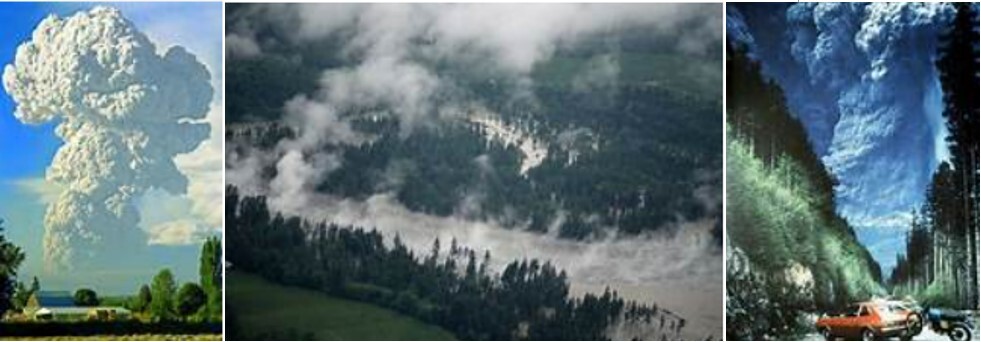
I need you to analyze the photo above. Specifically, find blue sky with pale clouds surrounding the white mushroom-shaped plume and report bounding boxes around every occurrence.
[0,3,224,294]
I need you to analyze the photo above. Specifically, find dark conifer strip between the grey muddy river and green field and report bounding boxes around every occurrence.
[225,187,685,340]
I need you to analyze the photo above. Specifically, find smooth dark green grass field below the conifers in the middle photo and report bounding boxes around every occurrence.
[225,271,453,340]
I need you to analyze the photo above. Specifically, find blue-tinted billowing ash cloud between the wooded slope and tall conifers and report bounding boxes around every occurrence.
[787,3,953,261]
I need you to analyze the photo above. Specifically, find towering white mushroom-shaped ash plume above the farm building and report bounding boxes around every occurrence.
[3,7,213,268]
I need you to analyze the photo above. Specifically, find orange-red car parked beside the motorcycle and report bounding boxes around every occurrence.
[815,302,915,341]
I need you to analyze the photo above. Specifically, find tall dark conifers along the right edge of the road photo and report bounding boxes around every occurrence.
[889,3,979,308]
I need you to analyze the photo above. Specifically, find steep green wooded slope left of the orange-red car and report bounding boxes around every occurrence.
[726,49,883,340]
